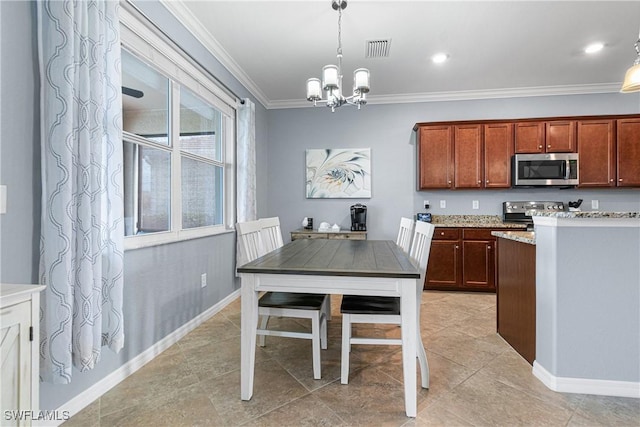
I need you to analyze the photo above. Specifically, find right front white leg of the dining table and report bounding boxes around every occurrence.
[400,279,418,417]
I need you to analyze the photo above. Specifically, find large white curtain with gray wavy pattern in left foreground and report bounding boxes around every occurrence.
[37,0,124,384]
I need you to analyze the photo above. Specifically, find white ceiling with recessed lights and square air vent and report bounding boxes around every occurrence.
[163,0,640,108]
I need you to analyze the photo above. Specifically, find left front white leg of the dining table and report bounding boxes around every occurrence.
[240,274,258,400]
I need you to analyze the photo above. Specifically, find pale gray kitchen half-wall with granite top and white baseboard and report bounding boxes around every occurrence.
[531,212,640,398]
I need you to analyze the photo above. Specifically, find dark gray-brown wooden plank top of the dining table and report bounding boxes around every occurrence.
[238,239,420,279]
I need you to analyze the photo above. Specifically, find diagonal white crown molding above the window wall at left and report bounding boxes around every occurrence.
[160,0,270,108]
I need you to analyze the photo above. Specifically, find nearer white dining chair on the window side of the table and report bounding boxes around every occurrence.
[236,218,328,379]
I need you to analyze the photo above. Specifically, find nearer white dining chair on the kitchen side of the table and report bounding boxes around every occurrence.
[340,221,435,388]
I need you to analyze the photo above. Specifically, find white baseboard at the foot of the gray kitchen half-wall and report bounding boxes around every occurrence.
[533,361,640,399]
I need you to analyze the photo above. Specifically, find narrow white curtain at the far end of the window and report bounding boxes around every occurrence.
[236,99,257,265]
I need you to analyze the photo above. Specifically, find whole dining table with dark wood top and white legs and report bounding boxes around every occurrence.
[237,239,420,417]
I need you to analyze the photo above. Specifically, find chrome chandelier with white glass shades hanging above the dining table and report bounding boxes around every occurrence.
[307,0,369,113]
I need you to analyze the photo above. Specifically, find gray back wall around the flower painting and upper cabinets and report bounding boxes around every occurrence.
[267,97,640,244]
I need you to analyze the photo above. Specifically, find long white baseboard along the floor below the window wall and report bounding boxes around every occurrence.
[52,289,240,425]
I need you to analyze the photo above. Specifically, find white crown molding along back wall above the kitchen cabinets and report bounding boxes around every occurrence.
[266,83,620,109]
